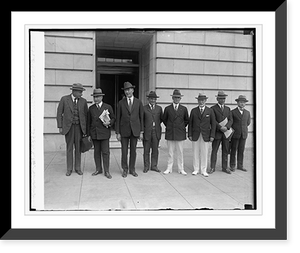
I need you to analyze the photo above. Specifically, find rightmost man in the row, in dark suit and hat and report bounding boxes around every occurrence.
[230,95,251,172]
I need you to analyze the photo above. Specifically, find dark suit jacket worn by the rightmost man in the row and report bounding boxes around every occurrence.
[231,108,251,139]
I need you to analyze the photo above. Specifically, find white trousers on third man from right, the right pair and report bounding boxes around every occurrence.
[192,133,210,173]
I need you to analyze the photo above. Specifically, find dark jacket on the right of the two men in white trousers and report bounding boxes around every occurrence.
[188,106,216,142]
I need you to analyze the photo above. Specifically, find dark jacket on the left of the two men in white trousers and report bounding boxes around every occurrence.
[163,104,189,141]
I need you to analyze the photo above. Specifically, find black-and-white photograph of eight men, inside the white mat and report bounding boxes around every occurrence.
[35,28,256,211]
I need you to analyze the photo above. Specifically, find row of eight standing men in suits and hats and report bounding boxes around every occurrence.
[57,82,250,179]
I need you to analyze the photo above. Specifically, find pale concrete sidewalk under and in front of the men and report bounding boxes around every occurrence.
[44,147,254,210]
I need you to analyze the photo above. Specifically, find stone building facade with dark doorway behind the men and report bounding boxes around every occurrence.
[44,29,255,151]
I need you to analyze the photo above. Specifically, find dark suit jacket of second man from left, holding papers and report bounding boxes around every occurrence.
[87,103,116,140]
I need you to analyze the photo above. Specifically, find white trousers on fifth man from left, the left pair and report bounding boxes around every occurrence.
[167,140,184,172]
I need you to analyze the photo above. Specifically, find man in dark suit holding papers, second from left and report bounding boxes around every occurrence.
[87,89,115,179]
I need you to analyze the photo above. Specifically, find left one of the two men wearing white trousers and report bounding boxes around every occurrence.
[163,89,189,175]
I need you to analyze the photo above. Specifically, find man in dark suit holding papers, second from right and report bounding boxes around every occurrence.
[208,91,232,174]
